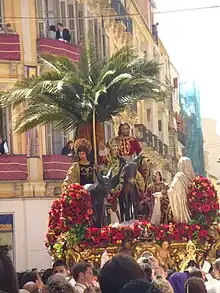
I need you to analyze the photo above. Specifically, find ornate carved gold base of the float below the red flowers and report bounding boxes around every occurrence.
[61,240,220,271]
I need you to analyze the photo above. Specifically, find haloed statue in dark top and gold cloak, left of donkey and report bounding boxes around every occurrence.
[63,139,94,187]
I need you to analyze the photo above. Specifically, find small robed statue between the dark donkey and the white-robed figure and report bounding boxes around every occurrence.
[147,170,172,225]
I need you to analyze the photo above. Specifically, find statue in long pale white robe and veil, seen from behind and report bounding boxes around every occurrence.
[168,157,196,223]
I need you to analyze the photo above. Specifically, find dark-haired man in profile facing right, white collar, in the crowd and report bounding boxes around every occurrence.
[72,262,93,293]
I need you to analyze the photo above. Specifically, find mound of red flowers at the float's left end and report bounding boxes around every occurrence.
[46,184,93,250]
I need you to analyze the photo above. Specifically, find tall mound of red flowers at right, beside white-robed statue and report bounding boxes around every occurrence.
[188,176,219,228]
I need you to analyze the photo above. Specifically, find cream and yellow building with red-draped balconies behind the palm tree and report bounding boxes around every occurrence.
[0,0,182,270]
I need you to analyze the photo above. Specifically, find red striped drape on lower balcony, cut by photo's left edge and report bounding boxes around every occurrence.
[0,155,28,181]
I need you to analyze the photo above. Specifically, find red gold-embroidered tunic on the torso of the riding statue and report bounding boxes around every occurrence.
[118,137,141,156]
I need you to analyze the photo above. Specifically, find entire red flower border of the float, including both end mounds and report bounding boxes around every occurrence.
[46,177,220,254]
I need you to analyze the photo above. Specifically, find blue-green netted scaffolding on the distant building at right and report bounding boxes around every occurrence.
[180,82,205,176]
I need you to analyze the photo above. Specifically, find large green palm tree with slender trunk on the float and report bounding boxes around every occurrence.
[1,45,163,163]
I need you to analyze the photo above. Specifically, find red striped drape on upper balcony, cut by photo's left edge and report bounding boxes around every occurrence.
[0,34,21,61]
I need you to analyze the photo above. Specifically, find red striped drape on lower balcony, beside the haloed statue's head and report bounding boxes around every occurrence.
[43,155,72,180]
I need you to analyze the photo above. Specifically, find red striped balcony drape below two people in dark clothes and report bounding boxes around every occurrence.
[38,38,80,62]
